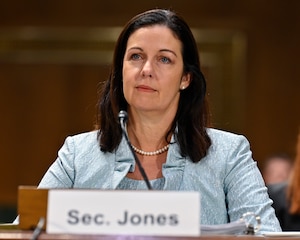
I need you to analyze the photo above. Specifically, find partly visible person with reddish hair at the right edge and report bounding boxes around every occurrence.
[268,132,300,231]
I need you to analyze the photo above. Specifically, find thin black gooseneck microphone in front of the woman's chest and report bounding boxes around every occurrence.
[119,110,152,190]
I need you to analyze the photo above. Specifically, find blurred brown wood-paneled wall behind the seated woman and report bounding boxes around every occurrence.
[0,0,300,222]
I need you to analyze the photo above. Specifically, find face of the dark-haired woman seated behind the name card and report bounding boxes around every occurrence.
[123,25,190,113]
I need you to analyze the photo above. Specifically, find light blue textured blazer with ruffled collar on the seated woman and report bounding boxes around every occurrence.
[39,129,281,232]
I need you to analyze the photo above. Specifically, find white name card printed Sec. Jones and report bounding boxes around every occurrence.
[46,189,200,236]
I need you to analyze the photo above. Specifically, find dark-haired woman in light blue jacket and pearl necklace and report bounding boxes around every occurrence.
[39,9,280,231]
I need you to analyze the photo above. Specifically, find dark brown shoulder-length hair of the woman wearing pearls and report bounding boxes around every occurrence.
[97,9,211,162]
